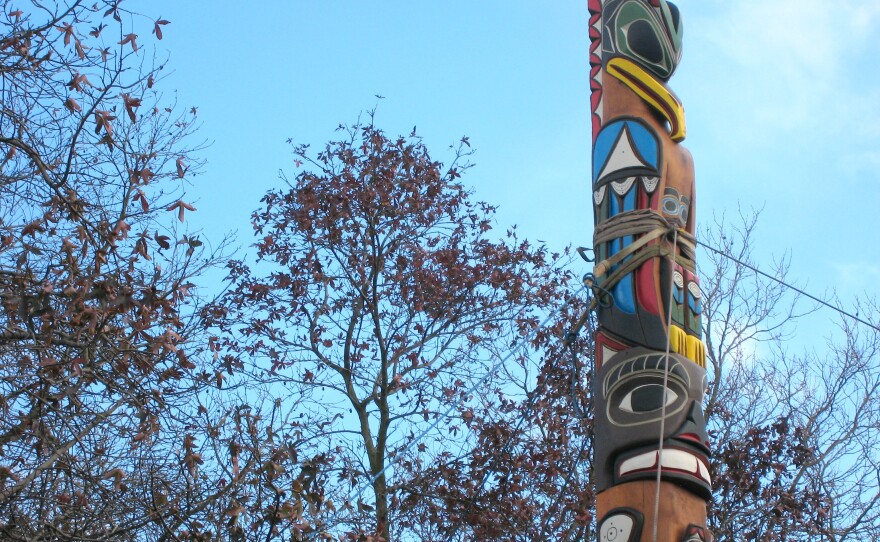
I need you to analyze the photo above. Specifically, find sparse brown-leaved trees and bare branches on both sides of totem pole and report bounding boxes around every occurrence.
[0,0,880,542]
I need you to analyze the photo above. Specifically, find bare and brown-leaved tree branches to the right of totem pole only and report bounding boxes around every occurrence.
[701,215,880,542]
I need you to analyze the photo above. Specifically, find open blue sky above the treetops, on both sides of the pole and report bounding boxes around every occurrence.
[146,0,880,340]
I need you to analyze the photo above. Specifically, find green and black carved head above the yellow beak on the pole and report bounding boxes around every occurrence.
[602,0,682,81]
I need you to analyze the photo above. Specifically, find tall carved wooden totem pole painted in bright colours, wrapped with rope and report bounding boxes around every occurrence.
[589,0,712,542]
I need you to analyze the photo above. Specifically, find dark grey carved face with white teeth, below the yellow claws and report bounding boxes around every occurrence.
[593,348,711,498]
